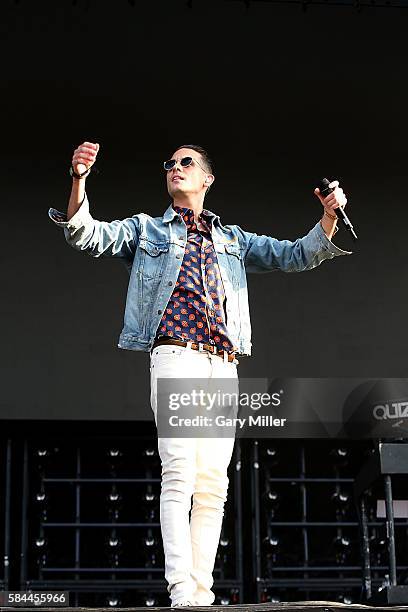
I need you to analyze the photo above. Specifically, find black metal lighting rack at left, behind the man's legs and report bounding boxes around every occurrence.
[20,438,243,607]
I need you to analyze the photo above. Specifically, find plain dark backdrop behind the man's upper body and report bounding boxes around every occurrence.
[0,0,408,419]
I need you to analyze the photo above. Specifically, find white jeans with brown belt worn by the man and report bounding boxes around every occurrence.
[150,345,238,606]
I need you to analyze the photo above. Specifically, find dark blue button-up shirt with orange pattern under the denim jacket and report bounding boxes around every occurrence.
[156,204,238,353]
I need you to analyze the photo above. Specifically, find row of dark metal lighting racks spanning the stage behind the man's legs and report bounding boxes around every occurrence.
[0,436,408,610]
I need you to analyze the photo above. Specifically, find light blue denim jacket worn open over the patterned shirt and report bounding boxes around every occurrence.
[48,194,351,355]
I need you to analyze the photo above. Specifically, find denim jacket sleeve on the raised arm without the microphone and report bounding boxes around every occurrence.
[48,193,140,259]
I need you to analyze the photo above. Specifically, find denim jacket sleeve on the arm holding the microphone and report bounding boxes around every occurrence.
[237,222,352,272]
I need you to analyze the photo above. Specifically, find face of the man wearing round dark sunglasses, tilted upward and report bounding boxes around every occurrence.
[167,149,211,198]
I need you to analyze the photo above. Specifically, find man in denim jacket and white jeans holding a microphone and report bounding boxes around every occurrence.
[48,142,349,607]
